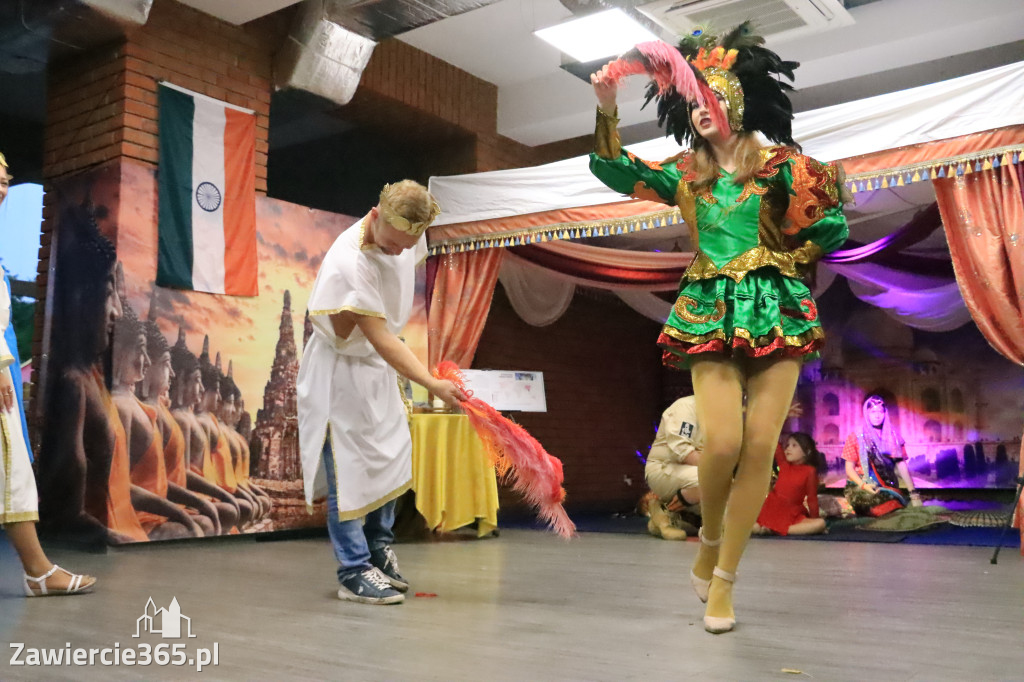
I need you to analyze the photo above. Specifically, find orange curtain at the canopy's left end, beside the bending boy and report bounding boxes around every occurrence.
[427,249,505,368]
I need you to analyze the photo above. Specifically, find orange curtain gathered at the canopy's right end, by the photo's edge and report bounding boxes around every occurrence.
[933,164,1024,366]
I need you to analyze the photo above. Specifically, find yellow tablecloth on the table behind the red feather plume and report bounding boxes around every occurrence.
[412,415,498,538]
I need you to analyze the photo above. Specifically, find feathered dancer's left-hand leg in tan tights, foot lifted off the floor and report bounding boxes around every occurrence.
[691,356,743,581]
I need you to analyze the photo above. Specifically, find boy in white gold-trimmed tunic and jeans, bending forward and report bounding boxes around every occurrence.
[298,180,463,604]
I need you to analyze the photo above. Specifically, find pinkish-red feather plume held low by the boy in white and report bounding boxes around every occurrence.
[433,360,575,538]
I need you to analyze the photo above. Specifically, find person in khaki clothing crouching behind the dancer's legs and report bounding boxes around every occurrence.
[644,395,703,540]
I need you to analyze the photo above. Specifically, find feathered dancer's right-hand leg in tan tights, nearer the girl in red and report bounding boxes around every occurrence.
[697,357,801,619]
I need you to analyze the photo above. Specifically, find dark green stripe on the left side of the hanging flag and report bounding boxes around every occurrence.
[157,86,196,289]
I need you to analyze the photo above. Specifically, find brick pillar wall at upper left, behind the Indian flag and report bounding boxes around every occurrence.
[33,0,289,417]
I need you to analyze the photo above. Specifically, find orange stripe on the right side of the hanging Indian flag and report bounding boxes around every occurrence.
[224,109,258,296]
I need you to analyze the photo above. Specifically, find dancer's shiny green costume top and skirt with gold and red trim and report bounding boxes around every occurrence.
[590,110,849,367]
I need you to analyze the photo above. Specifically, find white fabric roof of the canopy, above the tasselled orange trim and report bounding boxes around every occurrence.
[430,61,1024,225]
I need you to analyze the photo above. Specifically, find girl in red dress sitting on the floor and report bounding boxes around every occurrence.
[754,433,825,536]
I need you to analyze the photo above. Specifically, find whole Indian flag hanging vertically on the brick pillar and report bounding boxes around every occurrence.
[157,83,257,296]
